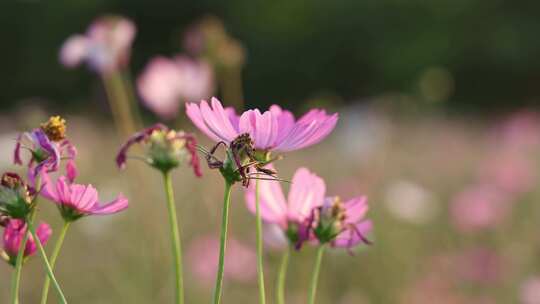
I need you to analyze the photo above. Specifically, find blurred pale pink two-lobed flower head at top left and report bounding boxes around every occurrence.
[60,16,136,73]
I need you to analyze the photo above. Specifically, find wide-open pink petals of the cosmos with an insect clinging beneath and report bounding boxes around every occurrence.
[186,98,338,152]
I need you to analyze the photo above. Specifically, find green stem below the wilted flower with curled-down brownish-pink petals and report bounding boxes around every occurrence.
[163,172,184,304]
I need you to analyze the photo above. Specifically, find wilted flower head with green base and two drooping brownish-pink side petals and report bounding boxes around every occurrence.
[116,124,202,177]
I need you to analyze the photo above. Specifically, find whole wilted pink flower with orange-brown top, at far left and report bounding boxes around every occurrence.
[14,116,77,180]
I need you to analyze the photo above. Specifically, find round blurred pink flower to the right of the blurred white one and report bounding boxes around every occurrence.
[450,185,510,232]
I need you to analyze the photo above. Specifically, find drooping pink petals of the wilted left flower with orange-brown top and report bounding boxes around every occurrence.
[13,128,77,180]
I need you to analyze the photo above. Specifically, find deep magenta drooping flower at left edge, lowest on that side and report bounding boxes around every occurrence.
[3,219,52,265]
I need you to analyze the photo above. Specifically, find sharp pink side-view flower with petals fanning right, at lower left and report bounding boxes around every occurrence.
[41,173,128,221]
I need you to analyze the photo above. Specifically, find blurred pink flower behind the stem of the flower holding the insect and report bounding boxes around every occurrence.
[187,237,257,285]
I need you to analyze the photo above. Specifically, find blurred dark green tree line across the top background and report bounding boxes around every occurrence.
[0,0,540,111]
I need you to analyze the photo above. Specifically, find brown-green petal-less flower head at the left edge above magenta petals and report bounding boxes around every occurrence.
[0,172,35,219]
